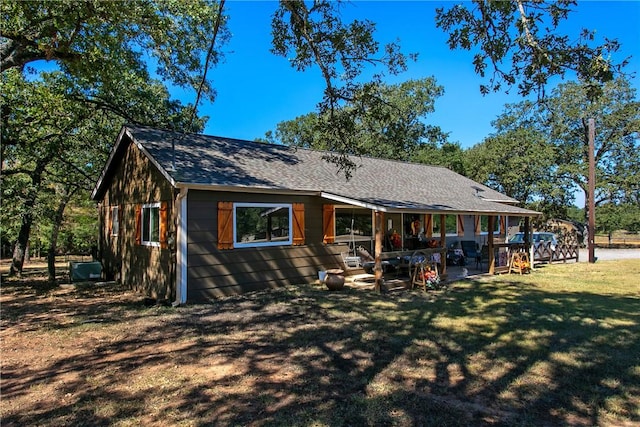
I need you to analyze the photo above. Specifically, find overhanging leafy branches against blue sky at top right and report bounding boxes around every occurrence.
[436,0,627,98]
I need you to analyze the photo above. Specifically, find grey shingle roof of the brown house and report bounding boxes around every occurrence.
[94,126,537,215]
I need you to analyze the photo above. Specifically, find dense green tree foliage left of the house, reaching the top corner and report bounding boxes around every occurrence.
[0,0,222,271]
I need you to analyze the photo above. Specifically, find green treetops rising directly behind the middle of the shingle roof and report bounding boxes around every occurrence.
[266,78,464,172]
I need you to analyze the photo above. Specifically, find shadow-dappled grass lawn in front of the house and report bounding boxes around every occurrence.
[0,260,640,426]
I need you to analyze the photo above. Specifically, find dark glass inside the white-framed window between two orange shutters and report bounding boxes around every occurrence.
[235,206,290,243]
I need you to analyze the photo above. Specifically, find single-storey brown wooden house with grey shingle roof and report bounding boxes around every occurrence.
[92,126,538,303]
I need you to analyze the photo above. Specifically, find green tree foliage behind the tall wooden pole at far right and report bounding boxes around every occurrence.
[543,78,640,205]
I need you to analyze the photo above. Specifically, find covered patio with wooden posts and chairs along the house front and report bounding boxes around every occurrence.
[322,191,540,289]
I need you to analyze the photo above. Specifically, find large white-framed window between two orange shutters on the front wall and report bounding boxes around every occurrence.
[233,203,293,248]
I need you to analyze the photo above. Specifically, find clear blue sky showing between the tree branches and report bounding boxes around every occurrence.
[188,1,640,148]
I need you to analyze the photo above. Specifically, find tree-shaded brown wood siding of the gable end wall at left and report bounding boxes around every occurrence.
[100,136,175,299]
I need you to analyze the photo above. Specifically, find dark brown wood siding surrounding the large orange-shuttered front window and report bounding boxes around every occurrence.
[187,190,345,301]
